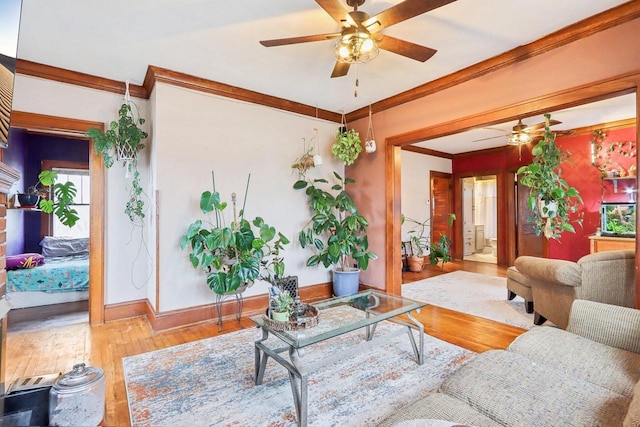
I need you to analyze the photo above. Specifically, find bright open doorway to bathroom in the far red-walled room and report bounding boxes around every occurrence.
[462,175,498,264]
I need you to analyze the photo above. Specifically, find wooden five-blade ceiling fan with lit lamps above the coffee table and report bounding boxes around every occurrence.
[260,0,455,78]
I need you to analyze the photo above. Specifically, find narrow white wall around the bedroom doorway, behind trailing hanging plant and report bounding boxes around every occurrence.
[13,74,155,304]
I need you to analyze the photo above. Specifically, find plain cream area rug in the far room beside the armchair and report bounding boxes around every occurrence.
[402,271,533,329]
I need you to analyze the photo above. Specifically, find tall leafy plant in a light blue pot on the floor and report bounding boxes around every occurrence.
[293,172,378,296]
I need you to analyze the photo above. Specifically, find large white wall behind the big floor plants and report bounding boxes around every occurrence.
[152,83,344,311]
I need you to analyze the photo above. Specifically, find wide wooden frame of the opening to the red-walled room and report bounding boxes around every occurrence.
[385,71,640,300]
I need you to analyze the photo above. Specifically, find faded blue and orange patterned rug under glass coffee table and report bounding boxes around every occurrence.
[123,322,475,427]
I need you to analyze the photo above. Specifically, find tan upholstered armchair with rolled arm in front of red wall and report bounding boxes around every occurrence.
[515,250,636,329]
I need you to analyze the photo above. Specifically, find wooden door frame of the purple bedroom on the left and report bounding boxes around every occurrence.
[11,110,105,325]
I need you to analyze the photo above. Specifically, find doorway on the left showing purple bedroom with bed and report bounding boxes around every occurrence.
[3,134,91,332]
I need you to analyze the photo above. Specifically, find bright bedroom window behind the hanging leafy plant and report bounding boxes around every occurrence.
[52,168,91,241]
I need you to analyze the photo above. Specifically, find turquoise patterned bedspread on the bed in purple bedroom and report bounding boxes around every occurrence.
[7,257,89,293]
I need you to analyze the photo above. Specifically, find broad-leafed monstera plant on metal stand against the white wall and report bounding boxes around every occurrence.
[180,174,289,295]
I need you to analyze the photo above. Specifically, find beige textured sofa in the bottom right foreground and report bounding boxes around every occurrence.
[381,300,640,427]
